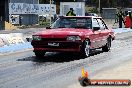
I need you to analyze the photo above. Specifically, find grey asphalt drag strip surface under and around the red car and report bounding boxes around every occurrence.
[0,32,132,88]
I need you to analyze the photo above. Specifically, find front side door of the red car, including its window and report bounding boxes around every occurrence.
[91,18,100,48]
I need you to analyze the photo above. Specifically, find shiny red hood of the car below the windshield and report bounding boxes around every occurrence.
[34,28,91,38]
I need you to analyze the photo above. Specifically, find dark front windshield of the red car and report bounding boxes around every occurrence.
[51,17,92,29]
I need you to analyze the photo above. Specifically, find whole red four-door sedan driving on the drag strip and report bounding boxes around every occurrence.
[31,16,115,57]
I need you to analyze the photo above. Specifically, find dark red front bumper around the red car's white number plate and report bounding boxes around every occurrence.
[31,41,82,52]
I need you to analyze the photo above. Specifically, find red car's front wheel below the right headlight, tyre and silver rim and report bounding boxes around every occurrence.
[81,40,90,57]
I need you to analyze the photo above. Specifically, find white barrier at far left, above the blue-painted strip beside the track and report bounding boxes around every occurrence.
[0,33,25,45]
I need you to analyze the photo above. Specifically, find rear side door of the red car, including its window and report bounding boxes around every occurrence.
[97,18,109,46]
